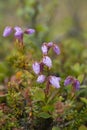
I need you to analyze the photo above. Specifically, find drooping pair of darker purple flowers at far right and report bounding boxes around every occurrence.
[64,76,80,90]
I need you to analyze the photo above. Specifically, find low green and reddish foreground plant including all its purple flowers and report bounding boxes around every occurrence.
[0,26,87,130]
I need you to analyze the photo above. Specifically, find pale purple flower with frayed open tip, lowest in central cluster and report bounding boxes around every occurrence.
[49,76,61,88]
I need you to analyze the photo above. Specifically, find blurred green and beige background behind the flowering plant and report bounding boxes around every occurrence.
[0,0,87,84]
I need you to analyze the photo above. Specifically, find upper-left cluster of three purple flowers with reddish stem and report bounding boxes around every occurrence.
[3,26,35,43]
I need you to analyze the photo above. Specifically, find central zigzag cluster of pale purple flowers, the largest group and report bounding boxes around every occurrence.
[32,42,61,88]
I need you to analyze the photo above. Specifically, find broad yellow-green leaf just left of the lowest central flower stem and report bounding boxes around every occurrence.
[34,88,45,101]
